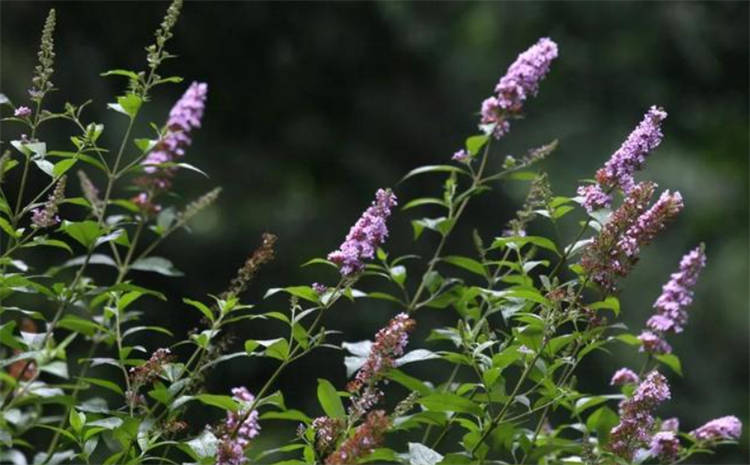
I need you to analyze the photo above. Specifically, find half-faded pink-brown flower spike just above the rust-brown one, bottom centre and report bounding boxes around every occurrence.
[347,313,416,416]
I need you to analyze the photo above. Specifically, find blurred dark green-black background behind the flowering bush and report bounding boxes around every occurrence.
[0,1,750,463]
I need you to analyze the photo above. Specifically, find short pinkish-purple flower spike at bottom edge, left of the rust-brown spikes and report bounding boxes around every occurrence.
[216,387,260,465]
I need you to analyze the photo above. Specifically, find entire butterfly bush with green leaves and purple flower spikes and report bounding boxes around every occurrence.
[0,0,742,465]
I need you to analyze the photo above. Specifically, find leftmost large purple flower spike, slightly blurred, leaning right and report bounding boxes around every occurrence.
[133,82,208,213]
